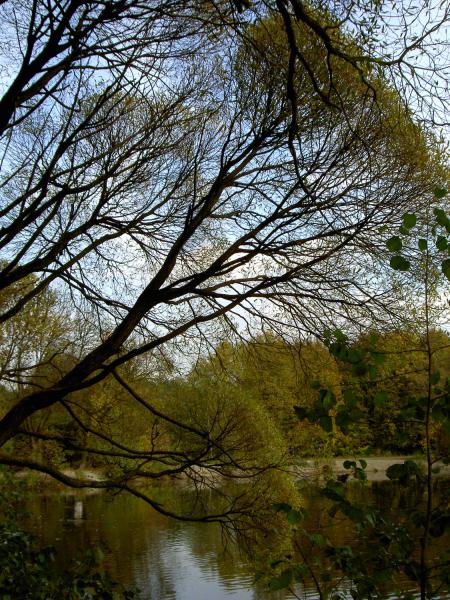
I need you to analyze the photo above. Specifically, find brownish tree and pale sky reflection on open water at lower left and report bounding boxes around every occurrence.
[21,490,266,600]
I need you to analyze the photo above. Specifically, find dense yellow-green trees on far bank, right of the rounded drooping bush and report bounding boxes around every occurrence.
[176,331,450,457]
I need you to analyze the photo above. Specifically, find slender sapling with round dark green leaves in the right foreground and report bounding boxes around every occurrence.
[264,188,450,600]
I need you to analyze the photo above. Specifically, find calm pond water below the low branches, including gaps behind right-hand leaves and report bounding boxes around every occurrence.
[19,482,450,600]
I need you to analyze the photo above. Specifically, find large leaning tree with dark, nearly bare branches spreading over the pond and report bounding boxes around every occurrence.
[0,0,448,520]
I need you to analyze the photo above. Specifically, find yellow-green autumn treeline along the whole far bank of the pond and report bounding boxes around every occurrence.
[0,284,450,472]
